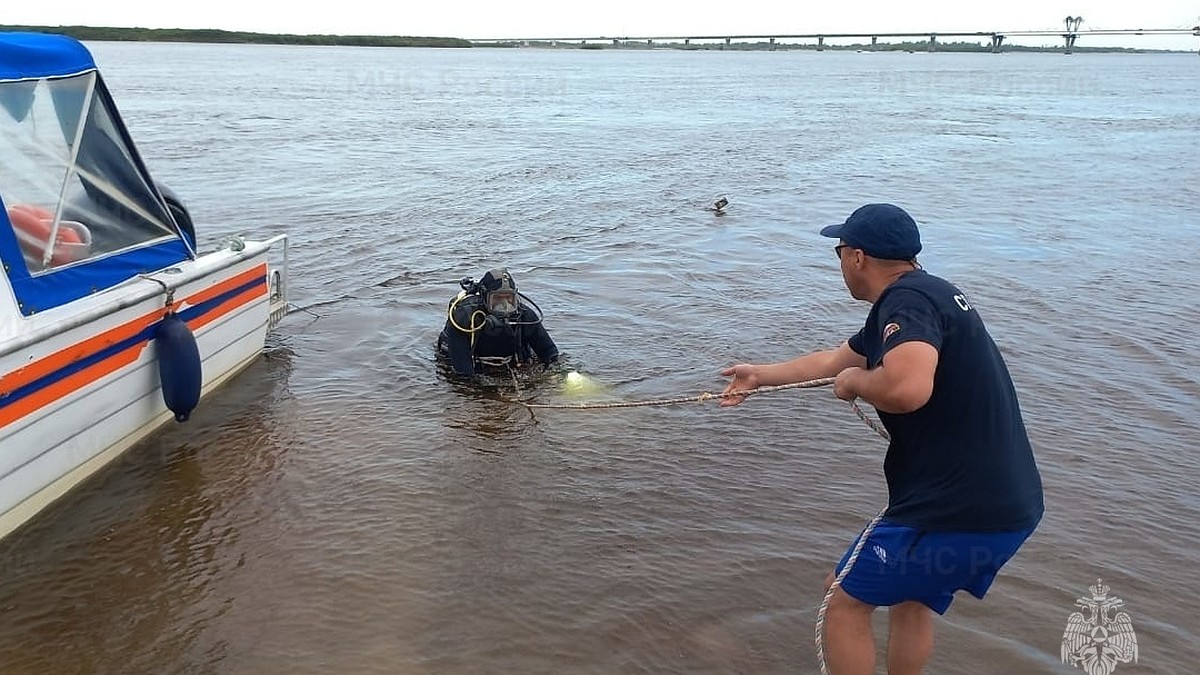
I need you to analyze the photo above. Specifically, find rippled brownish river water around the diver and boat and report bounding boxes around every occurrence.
[0,43,1200,675]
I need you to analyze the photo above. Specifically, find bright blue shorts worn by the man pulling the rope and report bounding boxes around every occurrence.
[834,520,1033,614]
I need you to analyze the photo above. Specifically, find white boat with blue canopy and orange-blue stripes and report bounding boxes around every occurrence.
[0,32,287,538]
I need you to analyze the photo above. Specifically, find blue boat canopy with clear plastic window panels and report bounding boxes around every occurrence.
[0,32,196,316]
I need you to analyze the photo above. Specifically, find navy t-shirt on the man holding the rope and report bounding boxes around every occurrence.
[850,269,1043,532]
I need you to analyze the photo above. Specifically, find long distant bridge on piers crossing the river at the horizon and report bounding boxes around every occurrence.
[472,25,1200,54]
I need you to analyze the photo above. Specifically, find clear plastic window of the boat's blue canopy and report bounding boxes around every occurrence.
[0,71,176,275]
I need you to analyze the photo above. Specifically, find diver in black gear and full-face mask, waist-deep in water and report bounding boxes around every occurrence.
[438,268,558,376]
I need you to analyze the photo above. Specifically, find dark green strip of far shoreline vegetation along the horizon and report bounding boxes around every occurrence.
[0,25,1187,54]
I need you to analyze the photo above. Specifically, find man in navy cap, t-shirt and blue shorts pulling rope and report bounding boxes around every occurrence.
[721,204,1044,675]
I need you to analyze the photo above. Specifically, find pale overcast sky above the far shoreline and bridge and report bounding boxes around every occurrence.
[7,0,1200,50]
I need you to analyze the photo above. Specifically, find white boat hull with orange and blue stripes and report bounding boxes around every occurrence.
[0,238,286,538]
